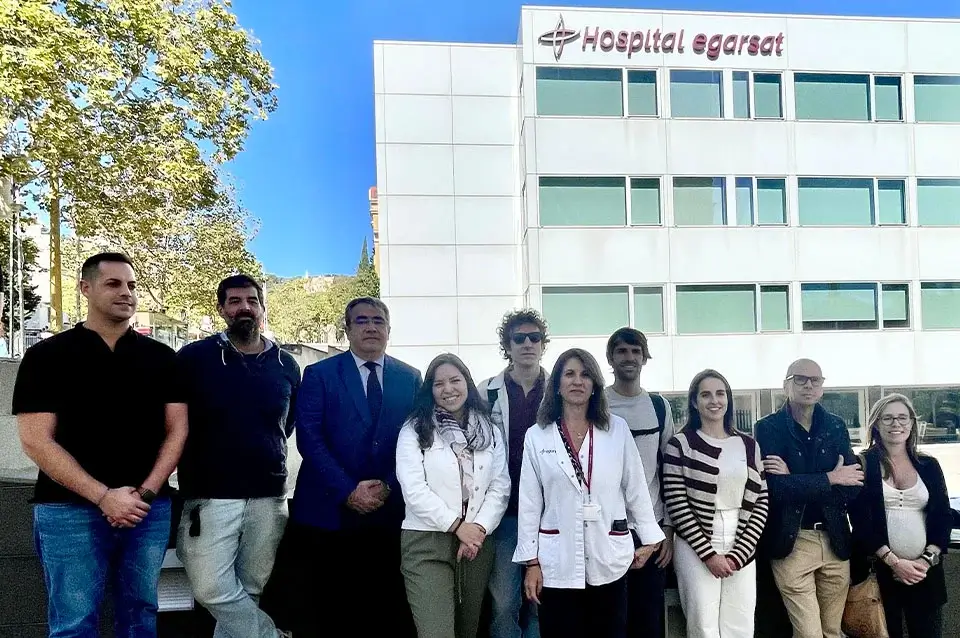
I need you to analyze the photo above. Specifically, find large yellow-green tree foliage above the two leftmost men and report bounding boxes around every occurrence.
[0,0,276,328]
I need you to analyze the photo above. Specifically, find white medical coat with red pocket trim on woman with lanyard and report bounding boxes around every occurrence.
[513,415,664,589]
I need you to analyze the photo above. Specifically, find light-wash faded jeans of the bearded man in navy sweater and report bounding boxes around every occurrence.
[177,497,287,638]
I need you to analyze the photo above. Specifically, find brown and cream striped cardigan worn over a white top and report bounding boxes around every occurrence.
[663,431,767,569]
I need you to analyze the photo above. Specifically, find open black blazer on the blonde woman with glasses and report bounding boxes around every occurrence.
[850,449,953,607]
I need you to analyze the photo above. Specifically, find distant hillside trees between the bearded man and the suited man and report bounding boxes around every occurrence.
[267,242,380,343]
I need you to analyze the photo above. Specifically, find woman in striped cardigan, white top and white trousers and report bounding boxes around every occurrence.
[663,370,767,638]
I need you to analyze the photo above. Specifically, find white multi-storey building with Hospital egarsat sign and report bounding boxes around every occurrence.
[374,7,960,452]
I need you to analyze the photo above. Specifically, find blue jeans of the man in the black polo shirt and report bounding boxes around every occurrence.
[33,498,170,638]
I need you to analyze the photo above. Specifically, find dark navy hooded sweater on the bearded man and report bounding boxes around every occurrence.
[177,335,300,498]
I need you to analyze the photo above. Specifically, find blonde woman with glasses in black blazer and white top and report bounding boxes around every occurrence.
[850,394,953,638]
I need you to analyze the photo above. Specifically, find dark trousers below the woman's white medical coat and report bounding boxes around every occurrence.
[540,576,627,638]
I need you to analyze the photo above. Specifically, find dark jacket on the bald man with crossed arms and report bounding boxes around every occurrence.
[756,405,860,560]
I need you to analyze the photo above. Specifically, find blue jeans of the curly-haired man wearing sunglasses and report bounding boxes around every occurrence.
[489,516,540,638]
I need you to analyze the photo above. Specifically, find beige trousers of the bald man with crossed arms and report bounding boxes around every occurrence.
[771,529,850,638]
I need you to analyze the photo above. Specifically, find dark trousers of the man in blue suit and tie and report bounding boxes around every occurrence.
[268,521,417,638]
